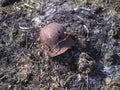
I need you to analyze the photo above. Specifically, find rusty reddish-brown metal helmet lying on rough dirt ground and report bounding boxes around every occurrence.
[40,23,74,57]
